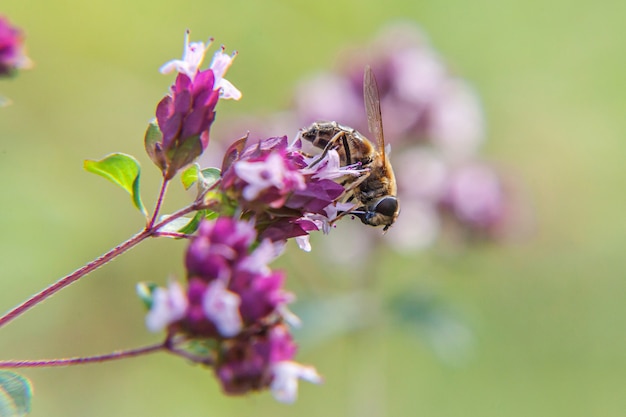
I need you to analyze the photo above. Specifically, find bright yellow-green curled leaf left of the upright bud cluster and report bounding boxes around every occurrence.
[84,153,148,216]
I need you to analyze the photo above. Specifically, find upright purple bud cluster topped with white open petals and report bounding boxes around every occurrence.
[145,32,241,180]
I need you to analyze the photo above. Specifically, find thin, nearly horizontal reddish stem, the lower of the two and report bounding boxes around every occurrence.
[0,342,168,369]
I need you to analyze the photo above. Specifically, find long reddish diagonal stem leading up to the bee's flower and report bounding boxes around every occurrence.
[0,203,197,327]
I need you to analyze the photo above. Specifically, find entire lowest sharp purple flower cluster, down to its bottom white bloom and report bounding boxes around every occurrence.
[146,217,321,402]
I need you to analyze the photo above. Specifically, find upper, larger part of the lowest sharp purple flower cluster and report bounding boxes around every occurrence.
[147,217,293,338]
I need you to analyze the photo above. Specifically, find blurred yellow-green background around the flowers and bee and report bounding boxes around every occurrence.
[0,0,626,417]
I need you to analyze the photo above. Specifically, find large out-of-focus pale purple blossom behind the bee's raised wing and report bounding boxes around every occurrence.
[294,24,484,156]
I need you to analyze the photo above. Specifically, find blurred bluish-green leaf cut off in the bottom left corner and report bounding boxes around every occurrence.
[0,371,33,417]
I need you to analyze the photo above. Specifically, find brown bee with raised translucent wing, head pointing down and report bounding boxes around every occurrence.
[300,66,400,231]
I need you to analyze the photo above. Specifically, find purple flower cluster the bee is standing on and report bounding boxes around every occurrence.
[221,136,363,250]
